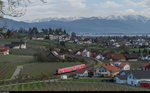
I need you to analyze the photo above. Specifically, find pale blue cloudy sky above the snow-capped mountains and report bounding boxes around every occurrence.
[5,0,150,21]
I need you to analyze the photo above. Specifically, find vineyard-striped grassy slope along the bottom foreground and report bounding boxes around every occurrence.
[0,82,150,91]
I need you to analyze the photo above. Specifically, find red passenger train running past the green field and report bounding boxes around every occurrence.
[56,64,86,74]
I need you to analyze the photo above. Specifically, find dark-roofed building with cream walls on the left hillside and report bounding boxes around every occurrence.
[5,42,26,49]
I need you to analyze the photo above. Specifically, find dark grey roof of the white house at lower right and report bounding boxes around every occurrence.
[131,70,150,79]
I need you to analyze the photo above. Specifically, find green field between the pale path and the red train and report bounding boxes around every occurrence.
[23,62,82,77]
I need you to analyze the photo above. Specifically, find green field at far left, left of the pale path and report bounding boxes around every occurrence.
[0,55,34,80]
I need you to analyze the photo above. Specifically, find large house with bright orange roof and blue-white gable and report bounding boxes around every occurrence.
[99,64,120,77]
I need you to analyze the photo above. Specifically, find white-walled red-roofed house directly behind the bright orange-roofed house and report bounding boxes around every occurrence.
[109,62,130,70]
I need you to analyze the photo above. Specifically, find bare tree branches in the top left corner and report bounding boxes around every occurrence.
[0,0,46,18]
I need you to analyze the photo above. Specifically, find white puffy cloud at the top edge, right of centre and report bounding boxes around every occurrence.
[100,1,123,8]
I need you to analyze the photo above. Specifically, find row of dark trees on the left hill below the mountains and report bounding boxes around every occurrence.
[0,27,68,39]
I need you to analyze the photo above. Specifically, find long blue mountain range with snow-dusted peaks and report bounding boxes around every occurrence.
[0,16,150,34]
